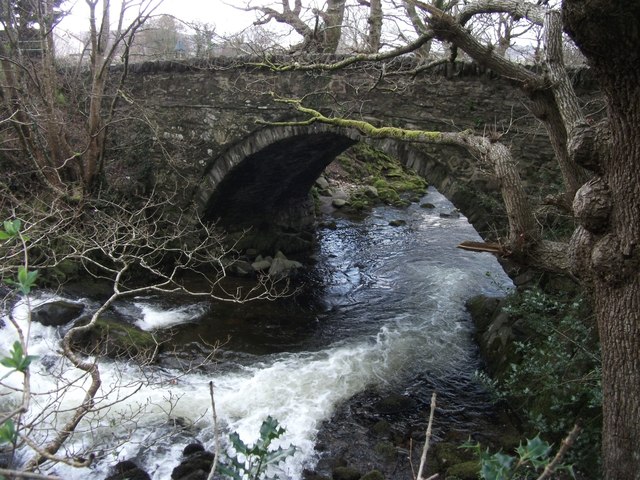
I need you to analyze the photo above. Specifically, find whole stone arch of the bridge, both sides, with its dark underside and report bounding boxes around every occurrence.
[196,125,498,253]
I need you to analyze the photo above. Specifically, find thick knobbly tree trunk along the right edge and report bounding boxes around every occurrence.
[563,0,640,480]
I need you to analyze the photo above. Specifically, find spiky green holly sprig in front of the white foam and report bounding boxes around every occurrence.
[218,416,296,480]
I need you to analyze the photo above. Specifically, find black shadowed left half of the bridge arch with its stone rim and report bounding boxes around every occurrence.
[196,124,360,226]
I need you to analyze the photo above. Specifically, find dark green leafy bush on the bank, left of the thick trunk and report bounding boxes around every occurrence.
[495,289,602,477]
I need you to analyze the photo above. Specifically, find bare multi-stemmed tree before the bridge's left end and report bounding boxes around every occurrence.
[0,0,162,194]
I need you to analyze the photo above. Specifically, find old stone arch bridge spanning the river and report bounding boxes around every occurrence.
[121,59,591,248]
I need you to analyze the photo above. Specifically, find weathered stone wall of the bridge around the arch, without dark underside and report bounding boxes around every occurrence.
[112,59,596,242]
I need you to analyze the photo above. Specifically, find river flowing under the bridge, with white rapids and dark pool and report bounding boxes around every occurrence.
[0,191,511,480]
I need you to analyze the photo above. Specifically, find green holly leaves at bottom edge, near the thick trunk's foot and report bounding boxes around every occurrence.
[462,436,575,480]
